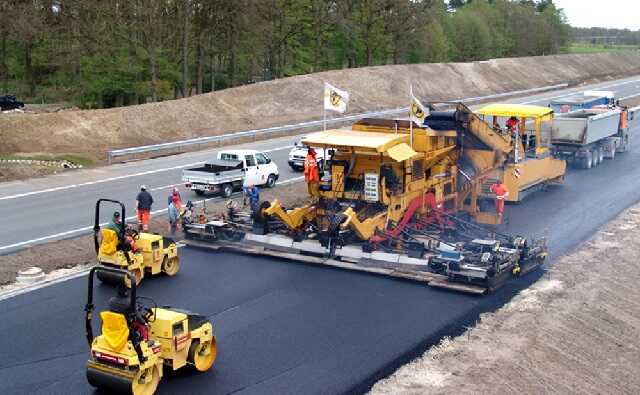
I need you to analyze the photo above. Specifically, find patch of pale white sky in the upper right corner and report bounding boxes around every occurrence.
[553,0,640,30]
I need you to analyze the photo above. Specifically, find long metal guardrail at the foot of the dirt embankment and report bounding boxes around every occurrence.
[107,83,569,164]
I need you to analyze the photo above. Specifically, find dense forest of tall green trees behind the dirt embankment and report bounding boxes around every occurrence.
[0,0,569,108]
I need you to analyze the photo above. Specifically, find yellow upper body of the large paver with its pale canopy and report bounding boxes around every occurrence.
[265,120,457,240]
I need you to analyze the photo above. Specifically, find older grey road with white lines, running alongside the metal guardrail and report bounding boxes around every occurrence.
[0,76,640,254]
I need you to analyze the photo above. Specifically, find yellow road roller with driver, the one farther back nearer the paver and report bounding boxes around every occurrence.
[93,199,180,284]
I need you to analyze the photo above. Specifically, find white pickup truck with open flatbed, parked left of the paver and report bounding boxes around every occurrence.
[182,150,279,197]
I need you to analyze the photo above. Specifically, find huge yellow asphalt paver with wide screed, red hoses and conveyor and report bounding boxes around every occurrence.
[185,104,547,293]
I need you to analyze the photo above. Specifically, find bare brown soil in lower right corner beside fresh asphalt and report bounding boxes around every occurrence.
[371,205,640,394]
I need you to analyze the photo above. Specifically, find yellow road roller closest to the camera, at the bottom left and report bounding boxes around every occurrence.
[85,266,217,395]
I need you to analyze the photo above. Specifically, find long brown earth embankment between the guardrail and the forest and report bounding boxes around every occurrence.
[0,52,640,160]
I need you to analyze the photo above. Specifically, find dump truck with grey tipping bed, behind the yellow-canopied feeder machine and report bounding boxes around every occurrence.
[550,106,629,169]
